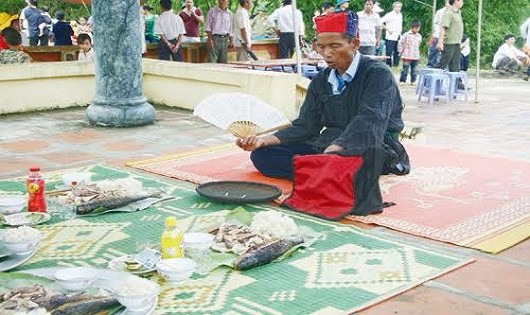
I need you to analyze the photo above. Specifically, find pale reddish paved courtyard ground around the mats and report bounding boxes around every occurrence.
[0,74,530,315]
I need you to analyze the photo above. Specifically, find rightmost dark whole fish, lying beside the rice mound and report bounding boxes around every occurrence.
[234,238,303,270]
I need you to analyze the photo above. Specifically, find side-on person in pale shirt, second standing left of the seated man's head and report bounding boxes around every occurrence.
[232,0,252,61]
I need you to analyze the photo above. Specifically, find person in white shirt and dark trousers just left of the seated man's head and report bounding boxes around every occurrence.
[267,0,305,59]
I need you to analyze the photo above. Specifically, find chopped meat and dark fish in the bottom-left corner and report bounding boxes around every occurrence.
[0,285,120,315]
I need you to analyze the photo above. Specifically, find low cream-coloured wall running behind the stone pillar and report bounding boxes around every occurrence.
[0,59,309,119]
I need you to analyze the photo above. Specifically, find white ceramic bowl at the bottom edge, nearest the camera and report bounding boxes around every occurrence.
[114,279,160,314]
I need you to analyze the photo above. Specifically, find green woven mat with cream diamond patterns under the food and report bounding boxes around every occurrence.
[0,165,470,315]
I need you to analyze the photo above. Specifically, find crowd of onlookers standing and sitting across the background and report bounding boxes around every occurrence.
[0,0,530,83]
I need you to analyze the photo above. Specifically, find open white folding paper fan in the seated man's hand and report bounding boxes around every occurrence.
[193,93,290,137]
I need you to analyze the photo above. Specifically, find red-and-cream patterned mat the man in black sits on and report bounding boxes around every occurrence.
[129,145,530,253]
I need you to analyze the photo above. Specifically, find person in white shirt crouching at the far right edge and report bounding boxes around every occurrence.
[492,34,530,73]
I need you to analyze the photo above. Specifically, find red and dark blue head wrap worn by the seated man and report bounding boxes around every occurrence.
[315,11,359,37]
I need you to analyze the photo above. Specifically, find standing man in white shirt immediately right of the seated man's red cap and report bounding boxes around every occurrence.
[357,0,381,55]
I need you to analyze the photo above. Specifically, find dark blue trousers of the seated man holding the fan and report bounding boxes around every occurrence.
[250,143,323,179]
